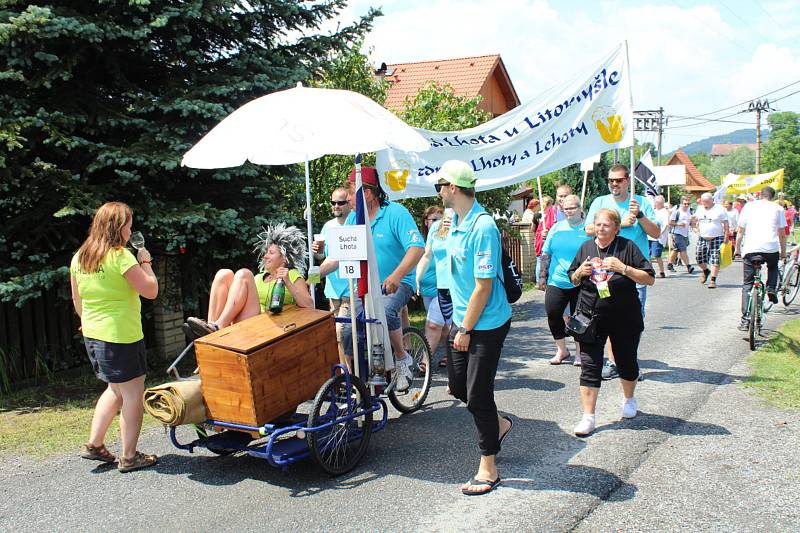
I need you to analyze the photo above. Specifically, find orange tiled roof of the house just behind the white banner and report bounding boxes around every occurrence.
[386,54,519,110]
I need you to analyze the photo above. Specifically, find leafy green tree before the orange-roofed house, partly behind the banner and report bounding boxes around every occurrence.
[399,83,516,224]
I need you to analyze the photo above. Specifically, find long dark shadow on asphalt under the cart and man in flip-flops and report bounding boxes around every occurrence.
[154,392,635,498]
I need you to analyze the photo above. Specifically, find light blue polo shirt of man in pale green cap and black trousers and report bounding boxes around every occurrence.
[446,201,511,330]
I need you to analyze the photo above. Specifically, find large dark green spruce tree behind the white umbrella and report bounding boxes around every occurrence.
[0,0,378,304]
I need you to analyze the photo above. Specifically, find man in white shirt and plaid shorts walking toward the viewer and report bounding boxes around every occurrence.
[692,192,728,289]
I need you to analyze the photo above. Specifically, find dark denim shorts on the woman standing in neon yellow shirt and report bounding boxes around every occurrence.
[83,338,147,383]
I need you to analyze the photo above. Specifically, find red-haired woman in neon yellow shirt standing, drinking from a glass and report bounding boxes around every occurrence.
[70,202,158,472]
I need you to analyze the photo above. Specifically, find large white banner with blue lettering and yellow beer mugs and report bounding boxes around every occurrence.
[377,44,633,200]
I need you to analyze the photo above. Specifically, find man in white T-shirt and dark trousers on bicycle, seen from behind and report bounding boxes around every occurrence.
[736,187,786,331]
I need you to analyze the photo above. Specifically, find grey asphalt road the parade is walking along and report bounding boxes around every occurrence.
[0,263,800,531]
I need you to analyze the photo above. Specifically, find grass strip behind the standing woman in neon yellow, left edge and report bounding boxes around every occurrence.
[0,370,166,458]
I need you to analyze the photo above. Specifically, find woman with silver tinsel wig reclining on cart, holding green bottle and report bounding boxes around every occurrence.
[184,224,314,338]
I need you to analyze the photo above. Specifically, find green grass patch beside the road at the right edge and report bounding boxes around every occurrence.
[745,319,800,410]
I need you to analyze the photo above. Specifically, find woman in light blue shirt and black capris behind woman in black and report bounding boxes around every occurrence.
[539,194,589,366]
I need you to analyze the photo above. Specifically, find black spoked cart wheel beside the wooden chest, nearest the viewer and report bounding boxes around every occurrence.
[306,374,372,476]
